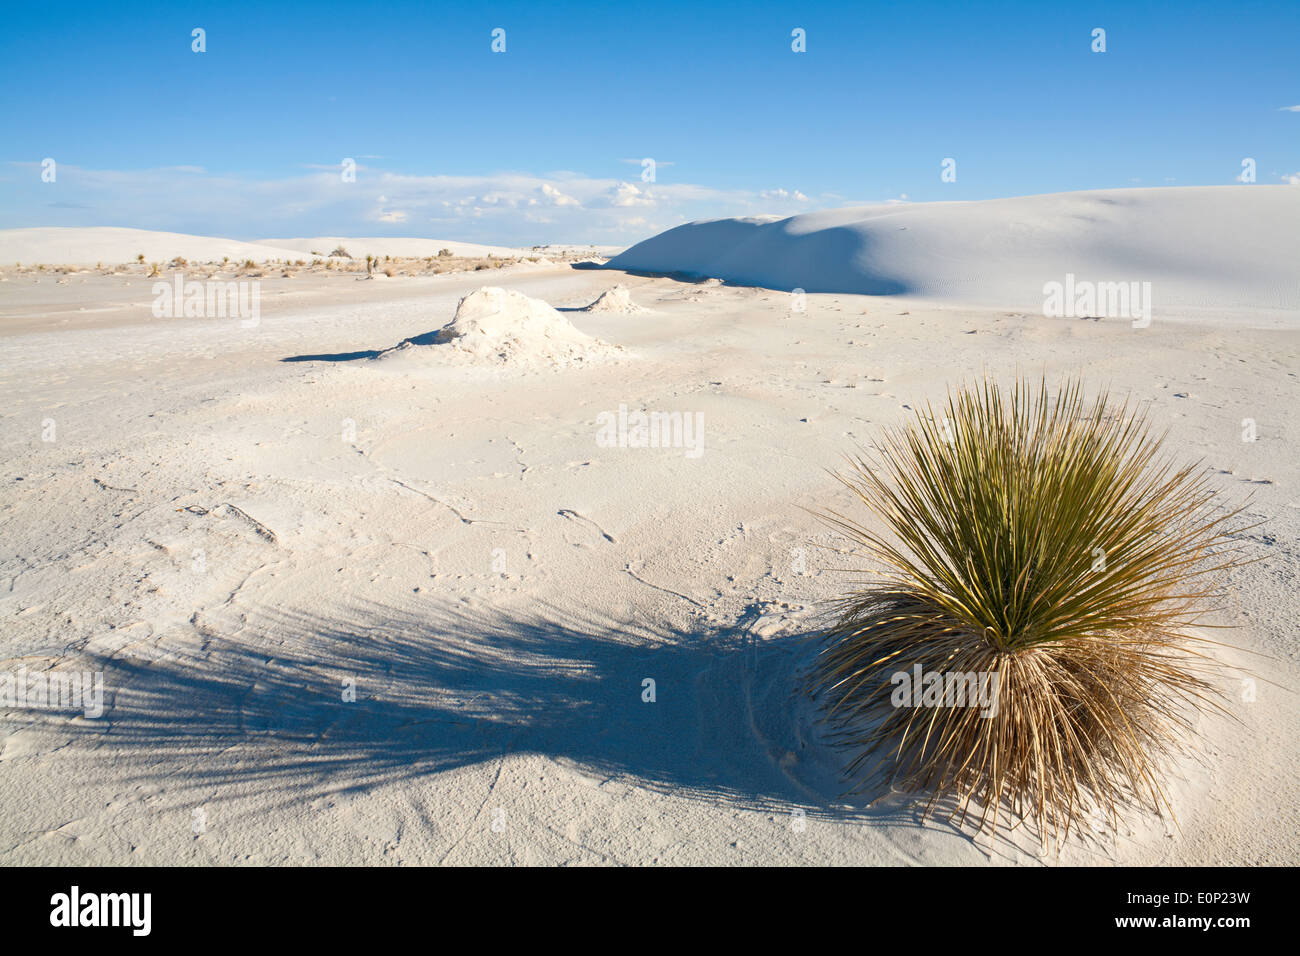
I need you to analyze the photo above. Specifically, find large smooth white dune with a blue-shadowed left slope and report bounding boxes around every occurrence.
[608,185,1300,312]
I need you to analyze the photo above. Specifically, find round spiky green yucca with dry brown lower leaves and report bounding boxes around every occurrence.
[811,380,1242,845]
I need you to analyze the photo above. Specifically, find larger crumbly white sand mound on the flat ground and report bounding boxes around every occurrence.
[377,286,625,368]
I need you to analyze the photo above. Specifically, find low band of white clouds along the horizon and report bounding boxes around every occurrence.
[0,163,824,246]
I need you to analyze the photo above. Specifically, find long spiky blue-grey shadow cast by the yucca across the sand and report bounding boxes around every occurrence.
[30,605,1045,858]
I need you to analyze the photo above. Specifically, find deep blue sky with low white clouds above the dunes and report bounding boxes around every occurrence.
[0,0,1300,245]
